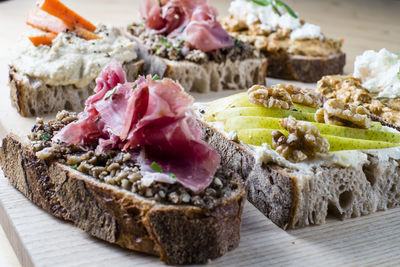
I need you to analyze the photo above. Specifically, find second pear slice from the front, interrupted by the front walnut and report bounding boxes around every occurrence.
[225,116,400,143]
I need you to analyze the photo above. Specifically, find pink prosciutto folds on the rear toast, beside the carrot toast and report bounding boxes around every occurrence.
[140,0,234,52]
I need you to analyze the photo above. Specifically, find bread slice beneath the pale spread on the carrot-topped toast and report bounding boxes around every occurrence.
[9,60,143,117]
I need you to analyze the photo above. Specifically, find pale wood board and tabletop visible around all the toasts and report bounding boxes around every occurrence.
[0,0,400,266]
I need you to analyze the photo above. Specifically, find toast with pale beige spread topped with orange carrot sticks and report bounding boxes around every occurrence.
[9,0,143,116]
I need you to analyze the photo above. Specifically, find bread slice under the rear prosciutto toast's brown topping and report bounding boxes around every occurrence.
[130,36,267,93]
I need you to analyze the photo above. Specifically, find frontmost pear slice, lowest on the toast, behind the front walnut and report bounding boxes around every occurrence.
[237,129,400,151]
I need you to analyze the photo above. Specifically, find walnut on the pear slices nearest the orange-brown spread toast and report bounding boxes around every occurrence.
[315,99,371,129]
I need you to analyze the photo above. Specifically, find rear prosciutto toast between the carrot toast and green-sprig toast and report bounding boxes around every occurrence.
[127,0,267,92]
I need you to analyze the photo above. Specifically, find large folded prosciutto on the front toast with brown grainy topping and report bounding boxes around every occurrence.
[52,62,220,193]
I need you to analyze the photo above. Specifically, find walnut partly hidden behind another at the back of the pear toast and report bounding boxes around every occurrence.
[273,84,322,108]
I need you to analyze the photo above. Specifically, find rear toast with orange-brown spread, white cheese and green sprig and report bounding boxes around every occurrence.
[222,0,346,82]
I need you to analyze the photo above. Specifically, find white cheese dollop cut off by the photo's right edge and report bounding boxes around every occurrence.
[354,48,400,98]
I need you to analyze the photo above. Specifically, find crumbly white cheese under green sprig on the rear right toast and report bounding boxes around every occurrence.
[228,0,323,41]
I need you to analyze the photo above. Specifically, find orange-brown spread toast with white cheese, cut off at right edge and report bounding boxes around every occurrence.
[317,49,400,130]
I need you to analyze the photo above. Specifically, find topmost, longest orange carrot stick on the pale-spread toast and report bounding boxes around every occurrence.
[36,0,96,32]
